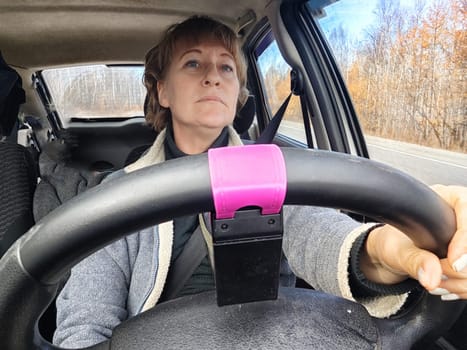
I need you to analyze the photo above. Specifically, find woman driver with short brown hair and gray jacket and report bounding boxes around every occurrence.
[54,17,467,348]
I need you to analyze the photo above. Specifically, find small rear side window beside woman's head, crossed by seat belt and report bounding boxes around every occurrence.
[255,33,307,144]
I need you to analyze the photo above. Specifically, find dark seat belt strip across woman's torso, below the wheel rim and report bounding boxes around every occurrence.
[160,220,208,301]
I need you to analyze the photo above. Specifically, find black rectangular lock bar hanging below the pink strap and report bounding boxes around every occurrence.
[212,209,283,306]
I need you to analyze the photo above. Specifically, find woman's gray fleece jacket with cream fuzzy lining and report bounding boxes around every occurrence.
[53,128,406,348]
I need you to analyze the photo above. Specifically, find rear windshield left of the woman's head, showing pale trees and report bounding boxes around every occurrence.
[42,65,145,125]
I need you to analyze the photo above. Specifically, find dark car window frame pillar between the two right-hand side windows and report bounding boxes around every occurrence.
[280,3,368,158]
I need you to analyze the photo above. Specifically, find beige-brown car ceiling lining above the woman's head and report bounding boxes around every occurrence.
[0,0,270,70]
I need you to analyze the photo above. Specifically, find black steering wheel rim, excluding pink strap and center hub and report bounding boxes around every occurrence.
[0,146,464,349]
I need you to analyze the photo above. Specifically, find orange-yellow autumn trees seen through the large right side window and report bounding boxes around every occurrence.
[346,0,467,152]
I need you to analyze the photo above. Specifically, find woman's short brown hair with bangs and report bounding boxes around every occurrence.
[143,16,248,131]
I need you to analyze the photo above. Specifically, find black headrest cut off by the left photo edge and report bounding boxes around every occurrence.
[0,52,26,136]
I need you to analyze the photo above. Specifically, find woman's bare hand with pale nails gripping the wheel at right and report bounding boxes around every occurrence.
[360,185,467,300]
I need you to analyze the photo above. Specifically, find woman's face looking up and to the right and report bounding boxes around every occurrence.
[157,41,240,135]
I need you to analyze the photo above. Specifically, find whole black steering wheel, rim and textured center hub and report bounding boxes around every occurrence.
[0,146,465,350]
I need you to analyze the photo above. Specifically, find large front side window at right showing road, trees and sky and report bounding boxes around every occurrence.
[318,0,467,186]
